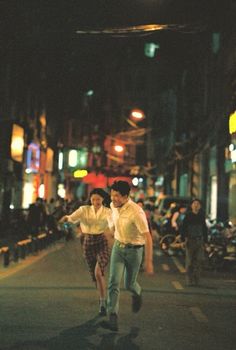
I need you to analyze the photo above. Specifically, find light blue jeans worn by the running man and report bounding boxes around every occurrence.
[107,241,143,314]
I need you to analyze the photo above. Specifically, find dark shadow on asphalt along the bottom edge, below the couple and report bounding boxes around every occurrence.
[4,317,140,350]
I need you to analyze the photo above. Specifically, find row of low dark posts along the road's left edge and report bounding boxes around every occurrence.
[0,230,66,267]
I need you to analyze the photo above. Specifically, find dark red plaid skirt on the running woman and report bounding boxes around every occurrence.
[83,233,109,282]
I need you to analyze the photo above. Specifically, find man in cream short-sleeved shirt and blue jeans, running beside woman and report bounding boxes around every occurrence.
[107,181,153,331]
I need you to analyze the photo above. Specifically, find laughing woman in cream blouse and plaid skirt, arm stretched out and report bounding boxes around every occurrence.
[59,188,111,316]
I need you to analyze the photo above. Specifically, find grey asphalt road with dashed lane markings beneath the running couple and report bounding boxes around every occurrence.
[0,239,236,350]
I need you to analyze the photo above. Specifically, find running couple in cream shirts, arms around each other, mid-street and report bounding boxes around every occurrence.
[60,181,153,331]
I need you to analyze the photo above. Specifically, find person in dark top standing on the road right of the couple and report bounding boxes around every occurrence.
[181,199,207,286]
